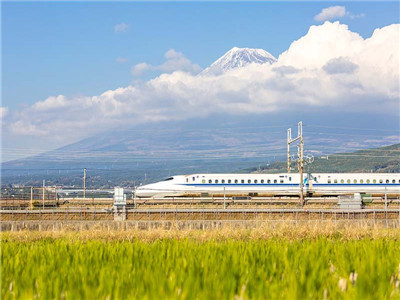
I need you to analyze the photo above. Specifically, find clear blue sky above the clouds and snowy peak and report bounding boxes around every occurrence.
[2,2,399,109]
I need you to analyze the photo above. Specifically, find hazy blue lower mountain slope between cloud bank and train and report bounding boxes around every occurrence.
[1,114,398,188]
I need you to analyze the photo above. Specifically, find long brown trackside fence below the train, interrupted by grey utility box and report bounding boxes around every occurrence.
[1,208,400,222]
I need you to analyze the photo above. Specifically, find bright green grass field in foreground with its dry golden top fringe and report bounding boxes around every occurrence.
[1,229,400,299]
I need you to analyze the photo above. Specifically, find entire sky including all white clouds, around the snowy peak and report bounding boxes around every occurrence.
[0,1,399,161]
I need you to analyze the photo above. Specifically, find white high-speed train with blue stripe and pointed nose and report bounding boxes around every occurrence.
[136,173,400,198]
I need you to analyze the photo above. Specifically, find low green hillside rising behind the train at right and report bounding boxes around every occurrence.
[249,144,400,173]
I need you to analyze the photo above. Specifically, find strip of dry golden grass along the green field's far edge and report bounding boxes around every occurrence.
[1,222,400,242]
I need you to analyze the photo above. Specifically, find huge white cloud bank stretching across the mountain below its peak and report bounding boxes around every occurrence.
[9,22,400,139]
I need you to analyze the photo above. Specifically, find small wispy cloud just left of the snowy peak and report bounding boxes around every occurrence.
[132,49,202,76]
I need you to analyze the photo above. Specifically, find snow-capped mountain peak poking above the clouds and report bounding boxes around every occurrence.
[200,47,276,75]
